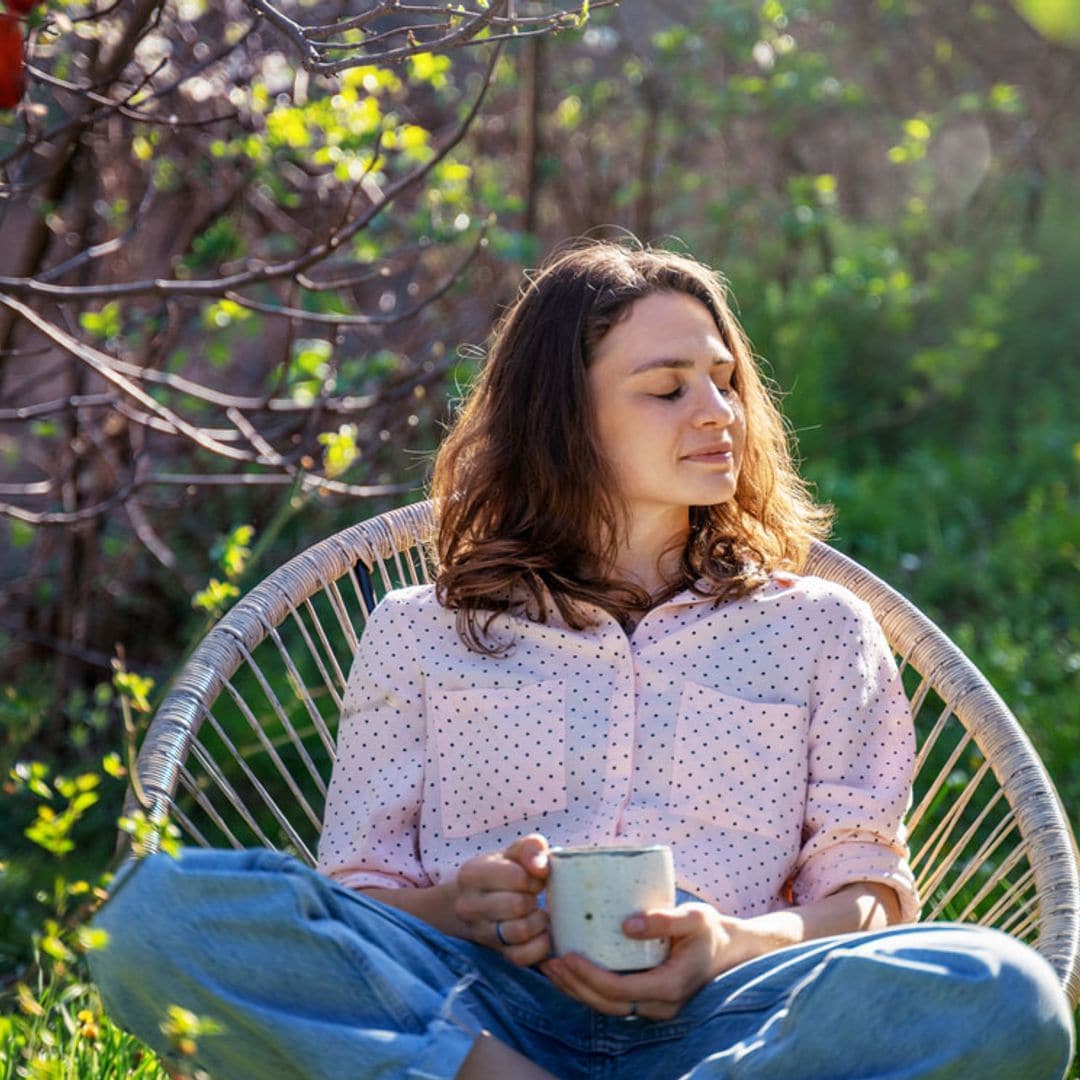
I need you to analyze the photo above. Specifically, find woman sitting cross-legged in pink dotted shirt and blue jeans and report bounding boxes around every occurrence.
[94,243,1071,1080]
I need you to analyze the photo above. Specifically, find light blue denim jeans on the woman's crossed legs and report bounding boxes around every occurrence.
[91,849,1072,1080]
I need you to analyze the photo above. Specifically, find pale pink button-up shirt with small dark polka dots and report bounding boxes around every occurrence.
[319,576,919,919]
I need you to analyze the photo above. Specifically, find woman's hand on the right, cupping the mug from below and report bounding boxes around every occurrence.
[540,903,768,1020]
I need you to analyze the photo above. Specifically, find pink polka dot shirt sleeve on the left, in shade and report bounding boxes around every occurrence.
[318,594,431,889]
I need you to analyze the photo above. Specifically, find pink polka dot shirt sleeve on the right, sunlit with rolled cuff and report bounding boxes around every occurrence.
[792,597,919,921]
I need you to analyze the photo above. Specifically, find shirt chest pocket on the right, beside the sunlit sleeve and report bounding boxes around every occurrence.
[669,683,808,847]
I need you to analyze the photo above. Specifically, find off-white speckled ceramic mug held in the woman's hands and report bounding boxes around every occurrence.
[548,843,675,971]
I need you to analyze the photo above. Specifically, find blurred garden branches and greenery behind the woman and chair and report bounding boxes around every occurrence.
[0,0,1080,1062]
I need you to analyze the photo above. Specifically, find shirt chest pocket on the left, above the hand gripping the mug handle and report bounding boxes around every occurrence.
[428,679,566,838]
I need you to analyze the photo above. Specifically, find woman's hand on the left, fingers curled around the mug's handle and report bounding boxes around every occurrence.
[454,833,551,968]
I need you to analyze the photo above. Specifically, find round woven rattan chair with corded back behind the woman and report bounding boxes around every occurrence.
[122,503,1080,1004]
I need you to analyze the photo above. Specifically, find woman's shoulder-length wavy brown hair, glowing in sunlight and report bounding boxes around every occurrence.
[432,241,832,653]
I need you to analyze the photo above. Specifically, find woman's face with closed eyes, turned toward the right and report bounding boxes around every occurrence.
[588,293,746,529]
